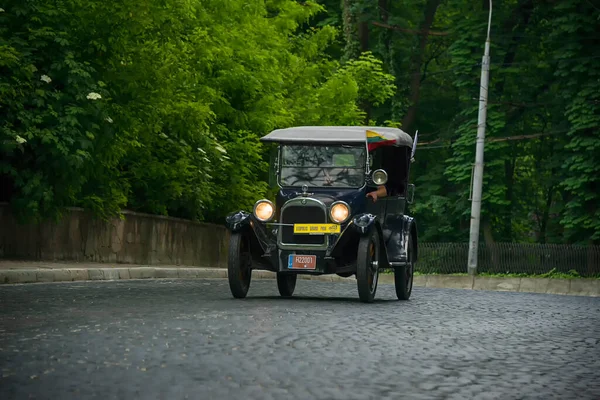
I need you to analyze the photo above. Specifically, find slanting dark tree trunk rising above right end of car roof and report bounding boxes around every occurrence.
[402,0,441,131]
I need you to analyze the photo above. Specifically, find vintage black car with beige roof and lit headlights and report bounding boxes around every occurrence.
[226,126,417,302]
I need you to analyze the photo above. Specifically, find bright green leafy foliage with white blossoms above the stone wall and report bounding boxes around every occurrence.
[0,0,393,221]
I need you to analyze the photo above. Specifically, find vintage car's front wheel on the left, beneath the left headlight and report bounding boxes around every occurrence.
[227,233,252,299]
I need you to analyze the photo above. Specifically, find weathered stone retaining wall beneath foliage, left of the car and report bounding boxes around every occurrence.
[0,204,228,268]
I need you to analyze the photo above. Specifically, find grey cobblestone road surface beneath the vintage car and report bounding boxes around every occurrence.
[0,280,600,400]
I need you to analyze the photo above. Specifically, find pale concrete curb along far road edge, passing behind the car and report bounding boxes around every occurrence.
[0,267,600,297]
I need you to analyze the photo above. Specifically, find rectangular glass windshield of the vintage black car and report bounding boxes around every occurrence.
[280,145,366,187]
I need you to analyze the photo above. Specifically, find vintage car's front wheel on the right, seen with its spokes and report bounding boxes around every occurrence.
[356,231,379,303]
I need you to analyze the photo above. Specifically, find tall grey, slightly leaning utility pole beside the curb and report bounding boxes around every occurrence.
[467,0,492,275]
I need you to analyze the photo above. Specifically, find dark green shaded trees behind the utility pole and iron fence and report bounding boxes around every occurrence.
[312,0,600,243]
